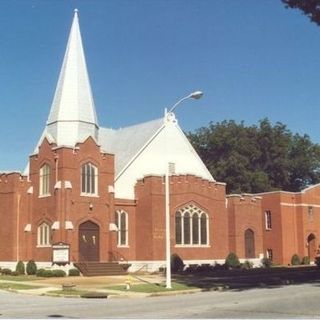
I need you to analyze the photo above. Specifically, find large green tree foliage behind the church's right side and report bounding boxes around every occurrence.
[188,119,320,193]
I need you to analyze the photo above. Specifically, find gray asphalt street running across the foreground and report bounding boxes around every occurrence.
[0,284,320,319]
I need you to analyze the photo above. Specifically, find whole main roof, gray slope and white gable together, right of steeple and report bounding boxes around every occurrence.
[99,114,215,199]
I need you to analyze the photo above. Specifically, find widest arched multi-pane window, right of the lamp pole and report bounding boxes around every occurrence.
[175,204,209,246]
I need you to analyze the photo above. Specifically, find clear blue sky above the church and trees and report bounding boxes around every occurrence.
[0,0,320,170]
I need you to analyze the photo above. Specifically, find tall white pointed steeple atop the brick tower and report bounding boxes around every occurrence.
[46,9,99,146]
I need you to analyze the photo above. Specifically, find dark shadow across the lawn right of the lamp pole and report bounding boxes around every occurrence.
[172,267,320,291]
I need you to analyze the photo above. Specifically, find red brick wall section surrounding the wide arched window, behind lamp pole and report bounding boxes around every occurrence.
[136,175,228,260]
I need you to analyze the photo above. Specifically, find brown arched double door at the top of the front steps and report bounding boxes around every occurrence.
[79,221,100,261]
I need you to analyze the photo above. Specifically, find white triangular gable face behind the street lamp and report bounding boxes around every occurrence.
[115,112,214,199]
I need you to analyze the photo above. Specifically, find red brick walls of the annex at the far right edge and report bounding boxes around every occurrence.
[262,186,320,264]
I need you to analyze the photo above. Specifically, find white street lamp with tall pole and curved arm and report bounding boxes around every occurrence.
[165,91,203,289]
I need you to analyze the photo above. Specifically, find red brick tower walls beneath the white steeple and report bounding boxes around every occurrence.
[26,138,114,261]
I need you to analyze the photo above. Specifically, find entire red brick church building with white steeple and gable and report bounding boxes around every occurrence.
[0,10,320,271]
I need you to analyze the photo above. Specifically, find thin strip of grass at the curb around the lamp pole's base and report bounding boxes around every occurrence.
[105,282,197,293]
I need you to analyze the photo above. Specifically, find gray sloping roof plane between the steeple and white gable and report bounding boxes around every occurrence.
[99,118,163,176]
